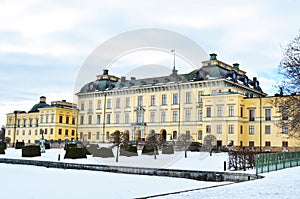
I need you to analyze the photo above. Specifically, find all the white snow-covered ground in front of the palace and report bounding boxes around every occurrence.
[0,148,300,199]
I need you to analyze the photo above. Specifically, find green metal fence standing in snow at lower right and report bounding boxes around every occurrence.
[255,152,300,174]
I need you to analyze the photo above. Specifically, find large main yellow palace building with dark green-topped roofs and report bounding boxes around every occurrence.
[76,54,300,150]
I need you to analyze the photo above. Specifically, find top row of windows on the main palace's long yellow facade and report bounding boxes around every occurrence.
[80,91,203,110]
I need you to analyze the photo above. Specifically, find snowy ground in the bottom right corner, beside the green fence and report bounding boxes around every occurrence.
[157,167,300,199]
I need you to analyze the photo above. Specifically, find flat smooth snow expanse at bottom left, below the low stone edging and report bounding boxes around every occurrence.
[0,164,228,199]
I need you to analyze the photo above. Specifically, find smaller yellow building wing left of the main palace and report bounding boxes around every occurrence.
[6,96,78,144]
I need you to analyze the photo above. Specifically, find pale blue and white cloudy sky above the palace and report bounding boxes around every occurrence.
[0,0,300,125]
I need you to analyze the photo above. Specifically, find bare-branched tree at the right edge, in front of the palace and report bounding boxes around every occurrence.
[278,32,300,137]
